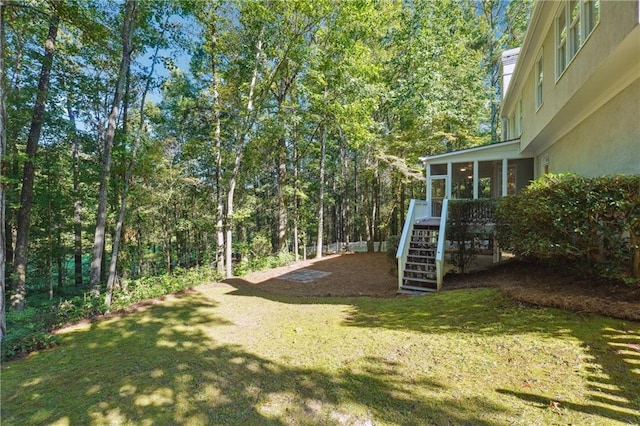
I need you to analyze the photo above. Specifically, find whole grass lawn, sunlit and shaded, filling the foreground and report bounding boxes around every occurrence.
[1,284,640,426]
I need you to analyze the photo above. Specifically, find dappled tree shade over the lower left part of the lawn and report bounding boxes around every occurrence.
[2,293,504,425]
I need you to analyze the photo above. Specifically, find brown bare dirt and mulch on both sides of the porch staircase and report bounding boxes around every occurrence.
[224,253,640,321]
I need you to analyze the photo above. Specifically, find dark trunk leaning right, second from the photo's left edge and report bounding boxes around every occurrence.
[11,10,60,311]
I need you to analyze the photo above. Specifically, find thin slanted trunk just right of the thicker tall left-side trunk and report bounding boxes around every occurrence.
[104,23,164,309]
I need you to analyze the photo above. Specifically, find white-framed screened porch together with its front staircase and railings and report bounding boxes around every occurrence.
[396,139,534,291]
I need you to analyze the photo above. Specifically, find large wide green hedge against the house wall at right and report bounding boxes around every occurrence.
[496,174,640,283]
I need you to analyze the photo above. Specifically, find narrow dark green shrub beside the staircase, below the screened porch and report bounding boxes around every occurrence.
[447,199,497,273]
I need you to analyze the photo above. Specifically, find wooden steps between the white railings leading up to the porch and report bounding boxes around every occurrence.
[401,219,440,291]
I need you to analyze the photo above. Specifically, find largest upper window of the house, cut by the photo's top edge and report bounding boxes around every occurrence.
[555,0,600,78]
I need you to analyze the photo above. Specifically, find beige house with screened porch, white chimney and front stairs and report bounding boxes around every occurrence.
[397,0,640,290]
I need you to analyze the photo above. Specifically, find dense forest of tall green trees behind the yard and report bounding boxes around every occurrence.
[0,0,531,338]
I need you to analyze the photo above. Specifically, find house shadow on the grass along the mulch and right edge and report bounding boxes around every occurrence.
[228,253,640,424]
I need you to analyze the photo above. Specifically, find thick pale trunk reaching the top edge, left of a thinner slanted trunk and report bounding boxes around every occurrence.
[89,0,137,296]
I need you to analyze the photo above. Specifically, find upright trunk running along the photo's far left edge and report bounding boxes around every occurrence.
[0,0,7,345]
